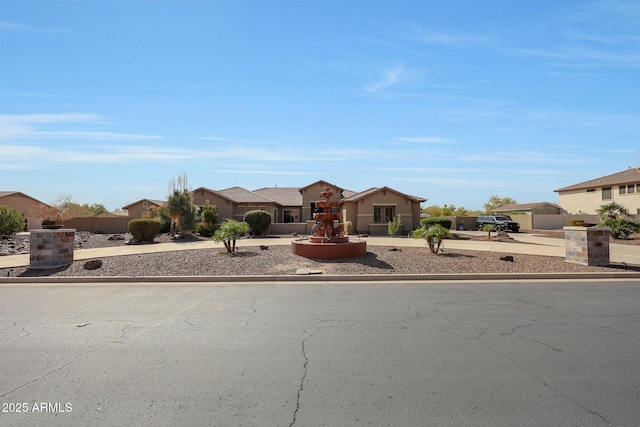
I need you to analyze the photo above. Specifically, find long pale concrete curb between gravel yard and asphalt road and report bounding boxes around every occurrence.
[0,271,640,286]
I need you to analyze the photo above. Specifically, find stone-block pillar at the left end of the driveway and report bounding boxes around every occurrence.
[29,229,76,269]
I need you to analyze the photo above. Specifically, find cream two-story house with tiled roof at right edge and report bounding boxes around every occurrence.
[555,168,640,214]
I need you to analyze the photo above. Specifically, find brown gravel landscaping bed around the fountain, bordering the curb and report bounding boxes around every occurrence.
[0,233,640,277]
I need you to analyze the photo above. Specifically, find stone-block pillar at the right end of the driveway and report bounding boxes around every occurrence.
[564,227,610,265]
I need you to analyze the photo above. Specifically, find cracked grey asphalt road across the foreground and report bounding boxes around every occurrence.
[0,281,640,427]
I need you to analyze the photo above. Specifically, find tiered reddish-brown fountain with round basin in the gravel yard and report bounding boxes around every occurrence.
[291,187,367,259]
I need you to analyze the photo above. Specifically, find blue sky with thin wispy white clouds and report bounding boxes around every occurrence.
[0,0,640,209]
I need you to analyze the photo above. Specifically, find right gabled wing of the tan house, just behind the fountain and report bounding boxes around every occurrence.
[340,187,426,234]
